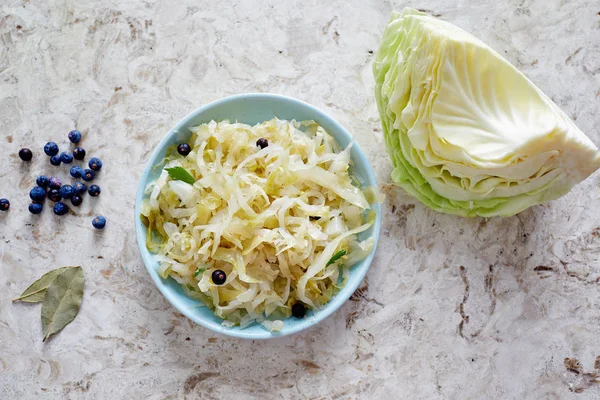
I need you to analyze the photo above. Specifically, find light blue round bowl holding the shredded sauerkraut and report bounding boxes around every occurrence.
[135,94,381,339]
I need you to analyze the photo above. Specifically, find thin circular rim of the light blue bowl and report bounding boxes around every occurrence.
[133,93,382,340]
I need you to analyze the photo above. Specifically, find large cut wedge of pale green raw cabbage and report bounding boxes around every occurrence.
[373,8,600,217]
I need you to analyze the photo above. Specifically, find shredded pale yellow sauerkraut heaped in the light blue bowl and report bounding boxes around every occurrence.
[141,119,374,331]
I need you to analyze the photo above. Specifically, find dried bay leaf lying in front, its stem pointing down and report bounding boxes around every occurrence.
[42,267,84,341]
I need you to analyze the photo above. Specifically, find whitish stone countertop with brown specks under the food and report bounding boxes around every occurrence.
[0,0,600,400]
